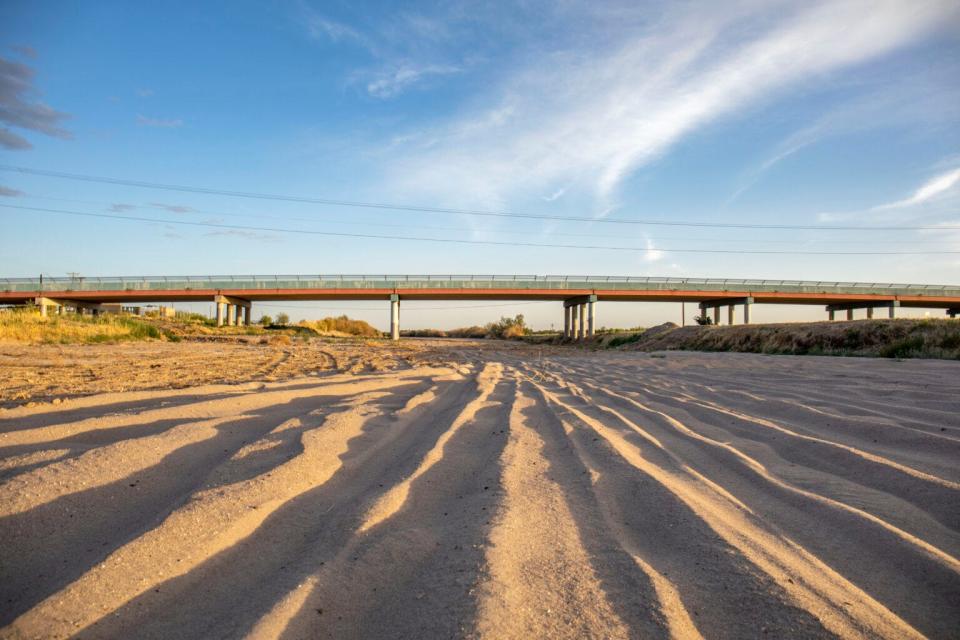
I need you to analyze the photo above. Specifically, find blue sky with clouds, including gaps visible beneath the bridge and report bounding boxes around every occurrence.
[0,0,960,328]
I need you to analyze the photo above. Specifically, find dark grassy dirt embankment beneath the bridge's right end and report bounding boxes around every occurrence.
[591,319,960,359]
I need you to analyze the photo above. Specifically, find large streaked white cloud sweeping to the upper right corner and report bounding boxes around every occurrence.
[384,0,958,208]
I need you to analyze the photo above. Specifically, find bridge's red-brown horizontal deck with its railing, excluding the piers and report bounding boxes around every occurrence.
[0,275,960,308]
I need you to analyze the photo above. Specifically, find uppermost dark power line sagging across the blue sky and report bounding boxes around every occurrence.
[0,164,960,231]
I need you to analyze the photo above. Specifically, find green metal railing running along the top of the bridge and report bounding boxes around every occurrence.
[0,275,960,297]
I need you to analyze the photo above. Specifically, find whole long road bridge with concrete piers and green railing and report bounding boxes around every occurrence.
[0,275,960,340]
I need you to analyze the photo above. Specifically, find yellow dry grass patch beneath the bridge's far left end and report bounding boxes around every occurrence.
[0,311,165,344]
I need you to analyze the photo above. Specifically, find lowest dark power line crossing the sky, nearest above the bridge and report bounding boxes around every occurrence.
[0,204,960,256]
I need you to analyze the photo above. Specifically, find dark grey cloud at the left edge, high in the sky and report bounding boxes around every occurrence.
[0,58,72,150]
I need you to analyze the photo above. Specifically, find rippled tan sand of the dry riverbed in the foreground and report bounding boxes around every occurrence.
[0,340,960,639]
